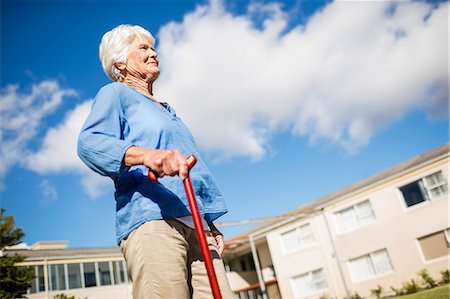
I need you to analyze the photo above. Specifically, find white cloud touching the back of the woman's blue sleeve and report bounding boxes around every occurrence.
[26,100,111,198]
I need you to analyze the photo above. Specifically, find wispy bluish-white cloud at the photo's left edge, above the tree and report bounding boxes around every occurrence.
[0,80,76,189]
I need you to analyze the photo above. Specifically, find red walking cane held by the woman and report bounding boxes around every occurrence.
[148,155,222,299]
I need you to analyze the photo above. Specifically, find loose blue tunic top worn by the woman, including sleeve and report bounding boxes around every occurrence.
[78,82,227,243]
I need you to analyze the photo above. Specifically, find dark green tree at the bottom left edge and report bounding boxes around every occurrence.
[0,208,34,299]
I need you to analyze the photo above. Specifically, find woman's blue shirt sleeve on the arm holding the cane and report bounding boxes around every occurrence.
[77,84,132,179]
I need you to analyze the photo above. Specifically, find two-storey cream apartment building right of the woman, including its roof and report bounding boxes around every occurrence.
[224,144,450,299]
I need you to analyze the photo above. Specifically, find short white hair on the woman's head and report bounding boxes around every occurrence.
[99,25,155,81]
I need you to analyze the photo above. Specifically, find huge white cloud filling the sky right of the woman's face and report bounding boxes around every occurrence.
[156,1,448,159]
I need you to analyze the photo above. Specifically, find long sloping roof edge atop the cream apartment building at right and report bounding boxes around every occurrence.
[225,143,450,250]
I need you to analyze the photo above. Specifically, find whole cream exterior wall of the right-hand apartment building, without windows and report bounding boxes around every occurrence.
[266,157,449,298]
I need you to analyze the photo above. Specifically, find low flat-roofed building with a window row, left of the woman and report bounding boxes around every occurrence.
[6,241,132,299]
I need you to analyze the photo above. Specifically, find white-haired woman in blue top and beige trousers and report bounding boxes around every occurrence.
[78,25,233,299]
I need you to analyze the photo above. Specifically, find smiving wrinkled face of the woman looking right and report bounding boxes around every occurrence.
[125,36,159,82]
